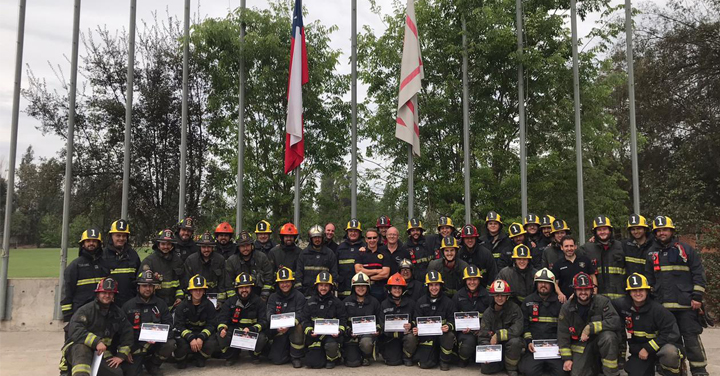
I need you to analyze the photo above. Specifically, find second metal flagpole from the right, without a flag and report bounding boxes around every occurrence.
[570,0,585,244]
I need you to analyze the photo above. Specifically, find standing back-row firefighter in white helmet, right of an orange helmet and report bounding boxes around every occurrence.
[295,225,338,295]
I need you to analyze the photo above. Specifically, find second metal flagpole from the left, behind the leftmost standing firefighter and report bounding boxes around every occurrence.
[55,0,80,318]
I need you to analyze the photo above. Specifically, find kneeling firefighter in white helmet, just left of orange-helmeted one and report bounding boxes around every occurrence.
[341,272,380,367]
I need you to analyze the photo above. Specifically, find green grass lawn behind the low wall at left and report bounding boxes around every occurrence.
[8,247,149,278]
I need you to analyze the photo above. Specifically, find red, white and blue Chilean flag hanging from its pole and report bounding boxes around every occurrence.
[285,0,310,174]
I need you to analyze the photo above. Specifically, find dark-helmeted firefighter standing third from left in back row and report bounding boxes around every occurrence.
[138,229,184,309]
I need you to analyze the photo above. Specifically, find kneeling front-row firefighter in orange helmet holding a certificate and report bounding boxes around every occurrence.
[377,272,419,366]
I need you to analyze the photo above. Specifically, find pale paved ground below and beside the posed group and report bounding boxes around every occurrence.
[0,329,720,376]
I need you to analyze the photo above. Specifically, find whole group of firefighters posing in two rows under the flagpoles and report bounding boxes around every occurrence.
[60,212,708,376]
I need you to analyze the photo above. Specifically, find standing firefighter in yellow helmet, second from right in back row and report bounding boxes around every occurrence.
[622,214,656,276]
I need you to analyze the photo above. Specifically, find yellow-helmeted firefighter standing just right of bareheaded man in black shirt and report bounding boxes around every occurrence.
[580,215,625,299]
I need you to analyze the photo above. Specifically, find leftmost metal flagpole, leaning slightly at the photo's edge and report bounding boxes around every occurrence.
[0,0,25,320]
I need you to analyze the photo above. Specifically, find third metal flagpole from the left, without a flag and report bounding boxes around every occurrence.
[120,0,137,219]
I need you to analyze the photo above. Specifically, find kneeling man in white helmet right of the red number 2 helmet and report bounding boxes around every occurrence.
[519,268,565,376]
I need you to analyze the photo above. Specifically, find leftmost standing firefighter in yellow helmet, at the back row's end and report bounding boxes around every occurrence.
[60,228,110,324]
